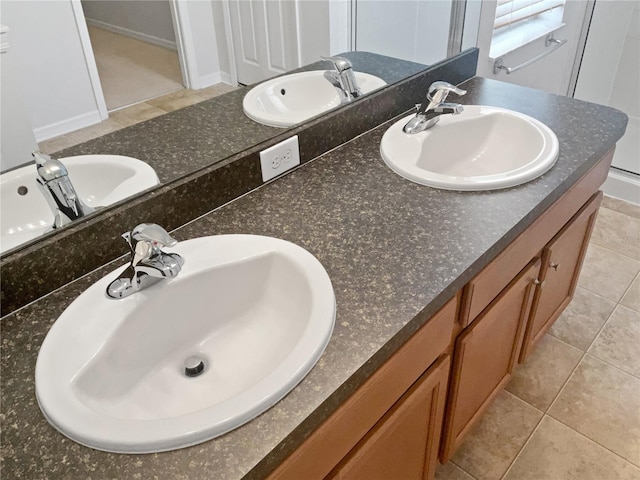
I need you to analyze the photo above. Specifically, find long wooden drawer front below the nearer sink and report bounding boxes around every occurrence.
[268,295,458,480]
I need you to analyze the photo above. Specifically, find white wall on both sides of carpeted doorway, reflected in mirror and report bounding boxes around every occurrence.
[0,0,228,146]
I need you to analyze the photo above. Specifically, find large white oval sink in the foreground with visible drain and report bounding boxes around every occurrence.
[36,235,335,453]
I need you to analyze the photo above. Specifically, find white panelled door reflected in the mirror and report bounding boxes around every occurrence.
[229,0,300,85]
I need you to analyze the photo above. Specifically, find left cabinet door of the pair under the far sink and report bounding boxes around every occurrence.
[441,259,540,463]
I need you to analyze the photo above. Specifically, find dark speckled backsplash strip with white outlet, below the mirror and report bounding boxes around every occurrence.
[0,49,478,316]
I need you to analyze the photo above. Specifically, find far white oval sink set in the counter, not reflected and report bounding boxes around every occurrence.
[380,105,558,190]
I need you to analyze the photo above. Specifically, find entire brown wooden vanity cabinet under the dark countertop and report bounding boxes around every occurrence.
[268,149,613,480]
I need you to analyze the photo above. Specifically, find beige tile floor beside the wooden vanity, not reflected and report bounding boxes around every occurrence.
[436,197,640,480]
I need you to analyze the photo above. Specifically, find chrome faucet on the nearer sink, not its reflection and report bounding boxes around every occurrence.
[107,223,184,298]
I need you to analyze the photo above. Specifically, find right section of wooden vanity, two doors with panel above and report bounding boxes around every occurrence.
[440,150,613,463]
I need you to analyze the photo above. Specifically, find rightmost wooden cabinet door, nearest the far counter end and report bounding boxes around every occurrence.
[520,192,602,362]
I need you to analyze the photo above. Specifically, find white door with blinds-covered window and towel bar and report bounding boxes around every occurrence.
[478,0,588,95]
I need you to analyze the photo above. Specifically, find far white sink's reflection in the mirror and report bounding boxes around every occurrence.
[242,70,386,127]
